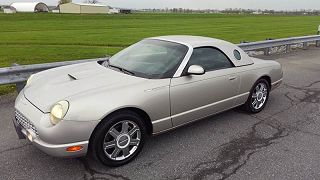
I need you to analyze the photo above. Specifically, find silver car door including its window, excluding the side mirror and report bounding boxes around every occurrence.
[170,47,240,126]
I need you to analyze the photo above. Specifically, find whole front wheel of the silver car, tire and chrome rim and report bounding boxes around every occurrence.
[90,111,146,166]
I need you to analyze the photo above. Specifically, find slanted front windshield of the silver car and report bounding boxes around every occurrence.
[106,39,188,79]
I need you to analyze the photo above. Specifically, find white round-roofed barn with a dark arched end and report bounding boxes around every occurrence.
[10,2,49,12]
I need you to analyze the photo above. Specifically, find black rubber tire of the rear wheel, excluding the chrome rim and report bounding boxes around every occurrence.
[243,79,270,114]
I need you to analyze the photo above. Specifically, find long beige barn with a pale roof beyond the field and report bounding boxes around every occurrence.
[59,3,109,14]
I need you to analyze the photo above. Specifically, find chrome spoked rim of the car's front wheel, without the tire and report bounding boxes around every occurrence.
[103,120,141,161]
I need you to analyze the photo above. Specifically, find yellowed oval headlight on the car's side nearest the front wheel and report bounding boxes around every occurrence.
[50,101,69,125]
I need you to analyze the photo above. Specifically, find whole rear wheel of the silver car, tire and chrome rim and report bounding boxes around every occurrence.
[244,79,270,113]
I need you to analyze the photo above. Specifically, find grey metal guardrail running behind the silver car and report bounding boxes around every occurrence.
[0,35,320,91]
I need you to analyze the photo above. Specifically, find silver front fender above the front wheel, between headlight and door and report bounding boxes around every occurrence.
[65,79,170,127]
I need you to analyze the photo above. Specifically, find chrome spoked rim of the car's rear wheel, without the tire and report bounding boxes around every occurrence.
[251,82,268,110]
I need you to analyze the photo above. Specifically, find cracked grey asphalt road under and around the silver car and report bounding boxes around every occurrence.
[0,48,320,180]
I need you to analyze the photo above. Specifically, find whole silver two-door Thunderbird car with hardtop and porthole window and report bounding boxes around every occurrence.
[14,36,283,166]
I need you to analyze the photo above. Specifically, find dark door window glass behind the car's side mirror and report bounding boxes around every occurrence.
[188,47,233,72]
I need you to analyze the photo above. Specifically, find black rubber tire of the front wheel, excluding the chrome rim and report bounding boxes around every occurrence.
[88,111,147,167]
